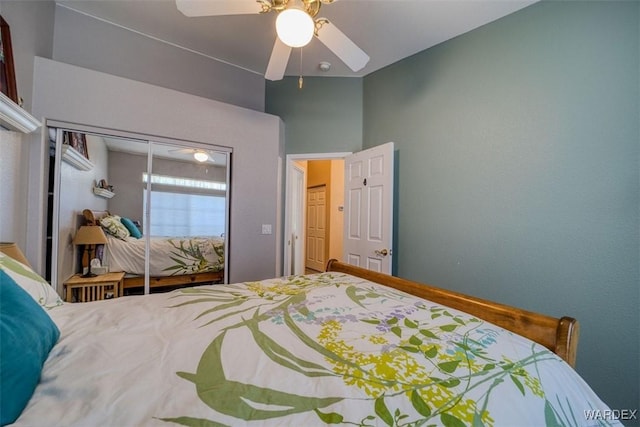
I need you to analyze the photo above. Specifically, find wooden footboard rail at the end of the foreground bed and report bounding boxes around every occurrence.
[327,259,580,367]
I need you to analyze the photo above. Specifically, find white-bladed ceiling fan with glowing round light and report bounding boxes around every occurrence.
[176,0,369,80]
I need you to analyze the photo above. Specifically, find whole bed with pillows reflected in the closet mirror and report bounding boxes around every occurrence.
[82,209,225,289]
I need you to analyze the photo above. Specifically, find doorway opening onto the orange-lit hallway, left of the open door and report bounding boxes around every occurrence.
[284,153,351,275]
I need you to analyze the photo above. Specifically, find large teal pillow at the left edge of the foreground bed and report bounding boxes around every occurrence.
[0,270,60,425]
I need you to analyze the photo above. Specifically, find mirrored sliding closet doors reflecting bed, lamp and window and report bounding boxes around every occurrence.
[47,122,231,301]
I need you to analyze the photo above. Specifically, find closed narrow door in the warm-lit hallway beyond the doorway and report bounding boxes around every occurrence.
[306,185,327,271]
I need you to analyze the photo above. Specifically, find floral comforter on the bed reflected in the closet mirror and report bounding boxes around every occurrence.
[102,236,224,277]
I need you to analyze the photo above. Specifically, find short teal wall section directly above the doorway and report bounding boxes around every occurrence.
[265,77,363,154]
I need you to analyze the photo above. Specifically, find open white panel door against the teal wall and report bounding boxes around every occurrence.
[344,142,394,274]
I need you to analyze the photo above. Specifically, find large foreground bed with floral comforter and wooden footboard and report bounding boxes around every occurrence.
[0,252,620,426]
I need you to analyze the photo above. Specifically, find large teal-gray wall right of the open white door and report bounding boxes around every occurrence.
[362,2,640,409]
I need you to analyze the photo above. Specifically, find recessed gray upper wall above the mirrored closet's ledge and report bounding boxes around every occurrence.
[52,6,265,111]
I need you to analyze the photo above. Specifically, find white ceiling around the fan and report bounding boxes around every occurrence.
[56,0,537,77]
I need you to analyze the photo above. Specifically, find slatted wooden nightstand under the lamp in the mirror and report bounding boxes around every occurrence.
[64,271,124,302]
